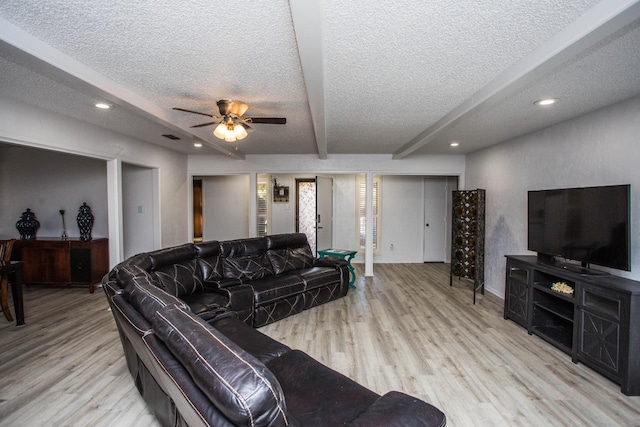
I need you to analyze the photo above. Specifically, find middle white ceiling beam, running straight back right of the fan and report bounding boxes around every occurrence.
[289,0,327,160]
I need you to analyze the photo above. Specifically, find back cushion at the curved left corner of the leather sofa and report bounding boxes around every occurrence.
[118,265,188,322]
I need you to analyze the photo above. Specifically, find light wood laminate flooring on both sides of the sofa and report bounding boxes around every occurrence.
[0,264,640,427]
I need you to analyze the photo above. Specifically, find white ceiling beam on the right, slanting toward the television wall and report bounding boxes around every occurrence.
[393,0,640,159]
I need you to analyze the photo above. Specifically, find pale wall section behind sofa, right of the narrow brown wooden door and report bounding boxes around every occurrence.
[202,175,249,241]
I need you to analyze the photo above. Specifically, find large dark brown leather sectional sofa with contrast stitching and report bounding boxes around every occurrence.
[103,234,445,426]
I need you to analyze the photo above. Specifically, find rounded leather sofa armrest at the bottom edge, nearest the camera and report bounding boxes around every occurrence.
[348,391,447,427]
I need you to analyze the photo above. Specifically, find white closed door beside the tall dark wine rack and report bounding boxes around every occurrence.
[424,177,448,262]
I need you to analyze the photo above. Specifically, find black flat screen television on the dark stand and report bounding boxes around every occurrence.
[528,185,631,273]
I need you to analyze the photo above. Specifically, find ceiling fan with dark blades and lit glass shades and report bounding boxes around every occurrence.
[173,99,287,146]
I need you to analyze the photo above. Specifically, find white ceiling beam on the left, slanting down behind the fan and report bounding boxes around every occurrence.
[0,18,245,160]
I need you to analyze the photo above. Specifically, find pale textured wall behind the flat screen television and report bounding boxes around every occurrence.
[466,98,640,296]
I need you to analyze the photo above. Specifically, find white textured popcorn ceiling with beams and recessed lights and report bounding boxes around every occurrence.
[0,0,640,159]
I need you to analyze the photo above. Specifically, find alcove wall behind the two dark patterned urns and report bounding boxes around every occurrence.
[0,145,108,238]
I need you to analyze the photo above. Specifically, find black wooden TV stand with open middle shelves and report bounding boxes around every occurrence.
[504,255,640,396]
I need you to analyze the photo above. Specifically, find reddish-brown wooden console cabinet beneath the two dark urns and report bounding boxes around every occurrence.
[12,238,109,293]
